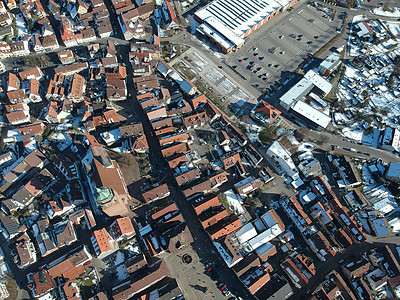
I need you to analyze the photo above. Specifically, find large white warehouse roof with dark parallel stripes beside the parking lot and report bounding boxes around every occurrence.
[195,0,284,45]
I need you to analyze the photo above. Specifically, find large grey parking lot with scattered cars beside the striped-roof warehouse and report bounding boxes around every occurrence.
[227,3,342,89]
